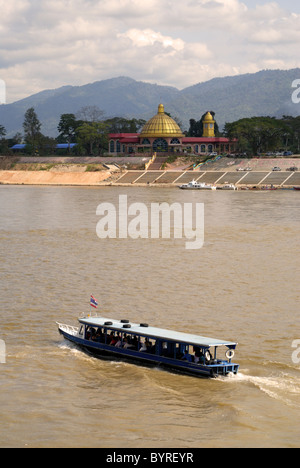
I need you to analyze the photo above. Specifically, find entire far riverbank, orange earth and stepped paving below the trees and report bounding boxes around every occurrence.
[0,157,300,189]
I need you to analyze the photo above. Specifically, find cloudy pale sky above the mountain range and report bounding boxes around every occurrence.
[0,0,300,103]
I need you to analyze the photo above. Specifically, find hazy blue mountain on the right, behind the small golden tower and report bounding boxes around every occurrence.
[171,68,300,128]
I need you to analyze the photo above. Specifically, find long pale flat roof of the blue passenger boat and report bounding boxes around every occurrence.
[78,317,237,348]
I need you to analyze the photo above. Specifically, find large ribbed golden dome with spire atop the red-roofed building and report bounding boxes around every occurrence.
[140,104,184,138]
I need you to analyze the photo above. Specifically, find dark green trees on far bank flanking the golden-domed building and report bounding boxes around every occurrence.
[0,106,300,157]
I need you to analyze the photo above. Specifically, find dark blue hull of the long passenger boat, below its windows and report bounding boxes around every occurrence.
[59,328,239,378]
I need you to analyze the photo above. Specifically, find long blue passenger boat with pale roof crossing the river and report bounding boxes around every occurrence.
[57,315,239,377]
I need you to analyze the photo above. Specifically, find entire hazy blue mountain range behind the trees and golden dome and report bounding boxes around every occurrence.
[0,68,300,137]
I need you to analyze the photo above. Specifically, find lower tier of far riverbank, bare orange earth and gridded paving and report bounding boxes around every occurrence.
[0,170,300,189]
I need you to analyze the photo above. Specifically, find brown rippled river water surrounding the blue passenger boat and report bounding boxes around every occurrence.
[0,186,300,448]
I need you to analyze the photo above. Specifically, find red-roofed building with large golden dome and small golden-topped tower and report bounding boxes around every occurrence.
[109,104,235,155]
